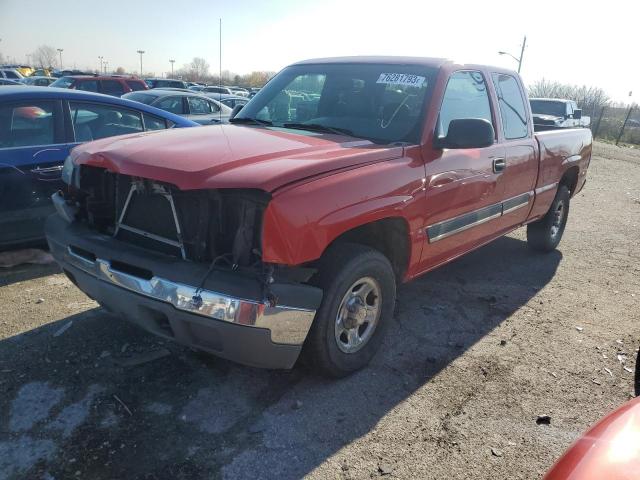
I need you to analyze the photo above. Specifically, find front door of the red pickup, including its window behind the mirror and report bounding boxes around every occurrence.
[423,70,504,268]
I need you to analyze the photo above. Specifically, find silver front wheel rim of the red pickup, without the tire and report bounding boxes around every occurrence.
[335,277,382,353]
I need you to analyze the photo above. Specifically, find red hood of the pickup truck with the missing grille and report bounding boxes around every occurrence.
[71,125,403,192]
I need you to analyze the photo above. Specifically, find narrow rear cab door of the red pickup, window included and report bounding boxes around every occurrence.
[491,73,538,225]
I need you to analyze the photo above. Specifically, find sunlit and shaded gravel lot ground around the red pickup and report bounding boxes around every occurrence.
[0,144,640,480]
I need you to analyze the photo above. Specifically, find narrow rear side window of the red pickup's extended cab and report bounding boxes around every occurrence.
[492,73,528,140]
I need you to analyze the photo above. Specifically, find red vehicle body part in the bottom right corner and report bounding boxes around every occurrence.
[545,397,640,480]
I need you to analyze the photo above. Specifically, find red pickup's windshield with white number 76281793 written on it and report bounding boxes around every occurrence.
[234,63,436,144]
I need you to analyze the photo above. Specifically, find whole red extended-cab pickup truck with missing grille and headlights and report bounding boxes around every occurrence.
[46,57,591,376]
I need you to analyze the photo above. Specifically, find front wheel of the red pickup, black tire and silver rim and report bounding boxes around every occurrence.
[303,244,396,377]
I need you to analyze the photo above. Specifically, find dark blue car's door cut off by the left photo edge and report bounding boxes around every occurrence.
[0,100,71,244]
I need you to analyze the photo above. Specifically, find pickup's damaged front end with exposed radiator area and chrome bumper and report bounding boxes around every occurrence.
[47,165,322,368]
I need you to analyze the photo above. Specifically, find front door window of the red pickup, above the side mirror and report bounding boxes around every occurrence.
[437,70,493,138]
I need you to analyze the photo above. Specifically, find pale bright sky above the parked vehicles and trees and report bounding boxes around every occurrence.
[0,0,640,103]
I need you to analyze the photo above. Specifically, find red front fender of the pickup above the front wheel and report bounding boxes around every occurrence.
[262,157,424,265]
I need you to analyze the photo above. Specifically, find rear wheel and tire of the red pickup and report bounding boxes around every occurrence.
[527,185,571,253]
